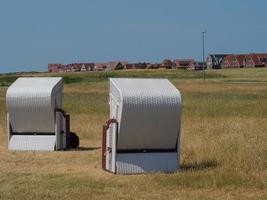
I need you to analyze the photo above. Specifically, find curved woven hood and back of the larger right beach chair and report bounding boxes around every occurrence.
[110,78,181,150]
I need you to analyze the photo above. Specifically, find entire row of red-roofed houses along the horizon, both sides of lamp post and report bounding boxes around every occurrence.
[48,53,267,72]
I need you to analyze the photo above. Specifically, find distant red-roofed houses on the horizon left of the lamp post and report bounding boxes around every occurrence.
[48,59,203,72]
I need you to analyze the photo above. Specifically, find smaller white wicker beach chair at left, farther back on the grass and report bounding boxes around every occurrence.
[6,77,69,151]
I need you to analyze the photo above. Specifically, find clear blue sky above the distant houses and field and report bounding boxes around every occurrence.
[0,0,267,72]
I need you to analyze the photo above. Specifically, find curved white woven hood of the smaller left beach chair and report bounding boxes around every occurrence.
[6,78,63,133]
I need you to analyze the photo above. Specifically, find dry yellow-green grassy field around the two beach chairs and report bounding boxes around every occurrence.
[0,68,267,200]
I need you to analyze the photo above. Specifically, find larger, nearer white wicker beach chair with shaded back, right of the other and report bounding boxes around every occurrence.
[102,78,181,174]
